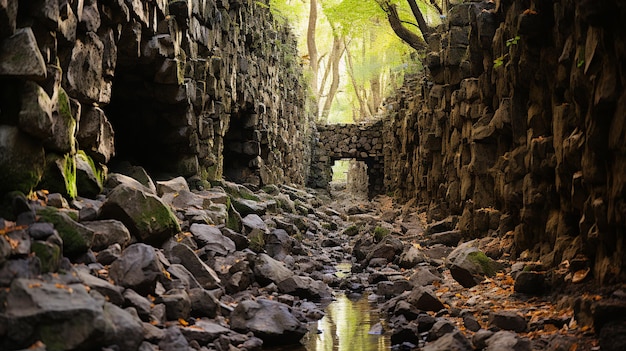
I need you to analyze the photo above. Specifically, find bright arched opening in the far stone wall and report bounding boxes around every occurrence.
[330,159,369,199]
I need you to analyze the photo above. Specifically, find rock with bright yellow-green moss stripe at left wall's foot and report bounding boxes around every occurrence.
[37,153,78,199]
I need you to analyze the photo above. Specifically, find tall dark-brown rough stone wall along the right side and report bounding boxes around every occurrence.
[384,0,626,283]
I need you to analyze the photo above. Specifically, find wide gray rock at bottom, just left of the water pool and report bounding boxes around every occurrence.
[230,299,307,345]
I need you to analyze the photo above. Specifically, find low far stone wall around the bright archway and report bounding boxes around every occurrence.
[309,120,384,197]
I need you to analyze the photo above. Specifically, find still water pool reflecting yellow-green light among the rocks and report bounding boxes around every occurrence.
[271,295,391,351]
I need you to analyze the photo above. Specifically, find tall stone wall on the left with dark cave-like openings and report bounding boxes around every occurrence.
[0,0,314,196]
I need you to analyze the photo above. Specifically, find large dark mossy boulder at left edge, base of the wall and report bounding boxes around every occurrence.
[0,125,46,194]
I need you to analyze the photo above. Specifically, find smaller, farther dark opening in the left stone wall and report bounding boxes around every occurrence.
[224,110,269,186]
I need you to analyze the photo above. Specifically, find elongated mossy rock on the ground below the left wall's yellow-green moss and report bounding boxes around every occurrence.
[37,207,94,257]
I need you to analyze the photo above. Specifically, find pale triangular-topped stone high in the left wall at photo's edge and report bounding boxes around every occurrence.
[0,27,47,80]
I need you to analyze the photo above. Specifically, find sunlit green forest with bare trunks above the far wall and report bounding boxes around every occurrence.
[266,0,448,123]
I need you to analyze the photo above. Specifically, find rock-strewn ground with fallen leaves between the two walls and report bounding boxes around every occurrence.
[0,169,626,351]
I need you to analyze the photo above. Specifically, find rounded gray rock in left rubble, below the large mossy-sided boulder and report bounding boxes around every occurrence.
[109,243,164,295]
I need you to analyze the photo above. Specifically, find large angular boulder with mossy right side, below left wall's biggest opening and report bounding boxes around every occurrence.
[100,184,180,245]
